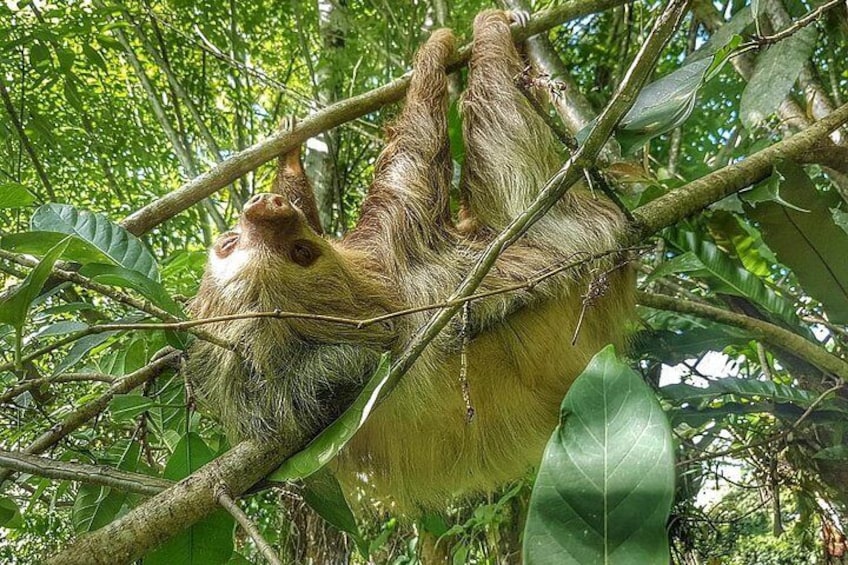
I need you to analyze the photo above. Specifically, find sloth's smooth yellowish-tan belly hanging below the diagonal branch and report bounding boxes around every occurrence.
[339,299,610,512]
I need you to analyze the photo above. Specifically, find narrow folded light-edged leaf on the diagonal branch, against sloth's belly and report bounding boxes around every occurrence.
[268,353,391,481]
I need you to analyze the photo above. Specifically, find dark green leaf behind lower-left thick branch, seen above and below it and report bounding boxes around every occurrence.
[144,432,234,565]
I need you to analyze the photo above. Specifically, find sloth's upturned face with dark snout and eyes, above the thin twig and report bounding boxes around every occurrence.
[192,194,394,341]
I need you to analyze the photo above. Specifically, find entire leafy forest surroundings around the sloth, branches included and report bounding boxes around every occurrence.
[0,0,848,564]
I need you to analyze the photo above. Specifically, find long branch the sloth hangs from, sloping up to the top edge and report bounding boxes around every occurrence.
[121,0,624,235]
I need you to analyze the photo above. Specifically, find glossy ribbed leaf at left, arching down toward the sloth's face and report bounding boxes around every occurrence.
[31,204,159,281]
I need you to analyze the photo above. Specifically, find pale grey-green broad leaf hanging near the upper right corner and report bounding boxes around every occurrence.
[739,26,816,131]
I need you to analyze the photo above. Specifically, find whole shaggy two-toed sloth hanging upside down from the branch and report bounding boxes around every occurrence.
[187,11,633,511]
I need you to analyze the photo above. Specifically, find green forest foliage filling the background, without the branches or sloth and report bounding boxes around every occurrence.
[0,0,848,564]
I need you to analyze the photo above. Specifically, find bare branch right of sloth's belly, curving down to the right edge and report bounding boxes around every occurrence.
[636,292,848,381]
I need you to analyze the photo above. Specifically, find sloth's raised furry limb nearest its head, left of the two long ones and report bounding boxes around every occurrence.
[348,29,455,262]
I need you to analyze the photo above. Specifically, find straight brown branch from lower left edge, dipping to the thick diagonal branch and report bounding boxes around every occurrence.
[0,449,174,496]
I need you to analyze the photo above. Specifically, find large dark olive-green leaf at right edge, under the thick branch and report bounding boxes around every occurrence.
[747,162,848,324]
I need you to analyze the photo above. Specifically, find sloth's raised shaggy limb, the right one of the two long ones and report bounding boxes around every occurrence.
[461,10,562,229]
